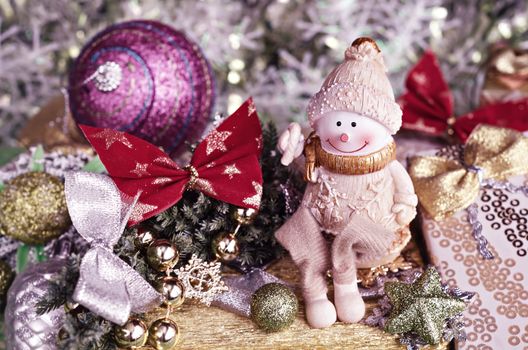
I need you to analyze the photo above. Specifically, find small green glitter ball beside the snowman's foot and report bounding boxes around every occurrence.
[251,283,299,332]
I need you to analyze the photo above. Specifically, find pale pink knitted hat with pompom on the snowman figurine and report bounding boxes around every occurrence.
[308,38,402,134]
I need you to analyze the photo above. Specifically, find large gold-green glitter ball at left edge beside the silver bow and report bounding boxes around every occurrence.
[0,172,71,244]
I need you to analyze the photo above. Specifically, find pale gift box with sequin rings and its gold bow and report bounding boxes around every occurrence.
[409,125,528,349]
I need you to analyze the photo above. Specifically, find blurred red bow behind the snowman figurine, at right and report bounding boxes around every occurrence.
[399,51,528,142]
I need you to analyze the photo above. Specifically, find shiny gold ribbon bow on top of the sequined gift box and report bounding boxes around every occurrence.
[409,125,528,220]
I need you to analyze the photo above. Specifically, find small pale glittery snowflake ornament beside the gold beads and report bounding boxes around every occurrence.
[176,255,228,306]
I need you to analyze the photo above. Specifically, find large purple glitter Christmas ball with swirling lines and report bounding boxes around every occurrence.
[68,21,215,155]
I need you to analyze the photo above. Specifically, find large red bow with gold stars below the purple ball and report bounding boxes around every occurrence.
[80,98,262,225]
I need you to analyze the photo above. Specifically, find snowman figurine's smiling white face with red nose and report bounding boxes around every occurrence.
[315,111,392,156]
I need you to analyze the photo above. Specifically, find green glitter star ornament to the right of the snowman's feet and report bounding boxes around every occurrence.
[385,267,466,344]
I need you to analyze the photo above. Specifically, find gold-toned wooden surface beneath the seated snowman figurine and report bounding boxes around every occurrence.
[138,242,447,350]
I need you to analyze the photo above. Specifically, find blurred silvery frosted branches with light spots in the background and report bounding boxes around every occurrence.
[0,0,528,145]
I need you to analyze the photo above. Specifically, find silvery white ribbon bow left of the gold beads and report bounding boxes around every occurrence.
[65,172,160,325]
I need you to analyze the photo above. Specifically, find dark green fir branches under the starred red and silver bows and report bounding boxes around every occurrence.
[37,120,304,350]
